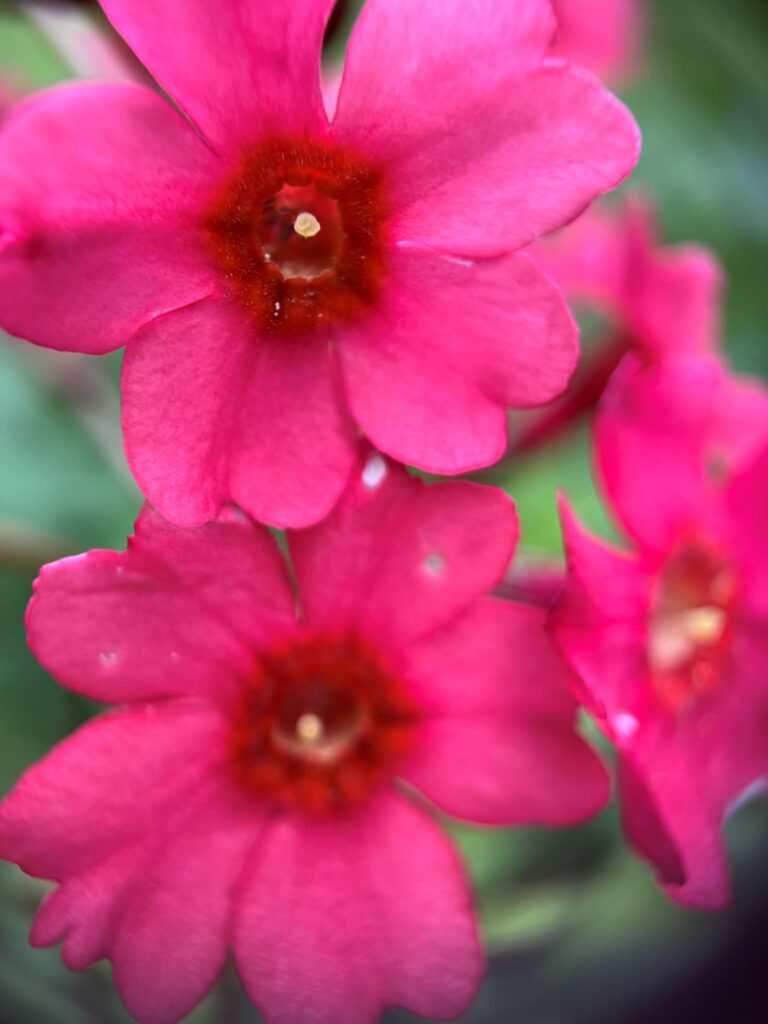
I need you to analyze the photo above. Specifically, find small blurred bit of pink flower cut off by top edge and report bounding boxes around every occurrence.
[552,0,644,82]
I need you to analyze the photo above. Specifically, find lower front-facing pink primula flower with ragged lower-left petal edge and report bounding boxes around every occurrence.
[0,455,607,1024]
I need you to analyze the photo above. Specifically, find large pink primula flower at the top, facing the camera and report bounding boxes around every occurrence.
[0,0,638,526]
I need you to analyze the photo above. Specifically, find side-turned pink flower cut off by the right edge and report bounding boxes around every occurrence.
[552,359,768,907]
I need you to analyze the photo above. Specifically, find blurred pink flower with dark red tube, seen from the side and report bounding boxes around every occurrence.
[513,197,723,452]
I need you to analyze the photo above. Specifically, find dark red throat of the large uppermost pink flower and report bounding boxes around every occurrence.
[205,139,386,335]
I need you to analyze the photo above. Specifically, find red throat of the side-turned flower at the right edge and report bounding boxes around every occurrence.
[648,540,737,711]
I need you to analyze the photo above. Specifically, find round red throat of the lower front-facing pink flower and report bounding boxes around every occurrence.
[230,633,416,813]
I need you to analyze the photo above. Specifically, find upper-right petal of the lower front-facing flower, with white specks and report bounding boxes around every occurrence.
[289,455,517,645]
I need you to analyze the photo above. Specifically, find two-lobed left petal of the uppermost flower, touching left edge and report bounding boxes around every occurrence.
[0,84,216,353]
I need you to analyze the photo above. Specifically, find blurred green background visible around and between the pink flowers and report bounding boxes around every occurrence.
[0,0,768,1024]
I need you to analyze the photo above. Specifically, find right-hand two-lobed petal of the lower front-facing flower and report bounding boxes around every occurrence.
[403,598,608,825]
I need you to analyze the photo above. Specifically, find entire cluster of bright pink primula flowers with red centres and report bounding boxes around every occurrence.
[0,0,768,1024]
